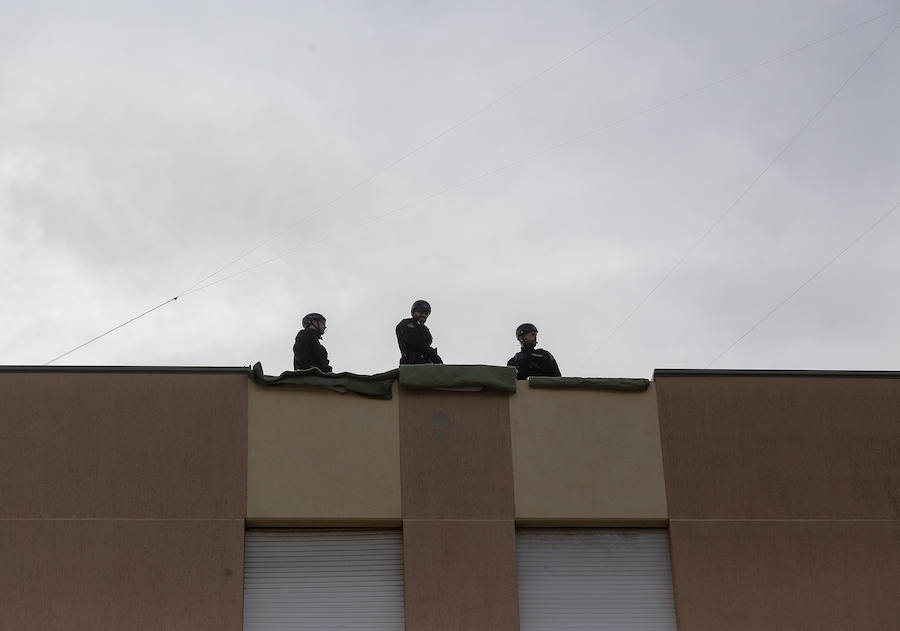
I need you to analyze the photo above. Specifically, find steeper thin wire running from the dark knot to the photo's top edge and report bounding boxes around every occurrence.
[179,0,664,295]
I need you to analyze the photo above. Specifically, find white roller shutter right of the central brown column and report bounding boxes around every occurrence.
[516,528,675,631]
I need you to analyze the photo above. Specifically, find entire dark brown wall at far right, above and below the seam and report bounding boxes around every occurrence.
[656,371,900,631]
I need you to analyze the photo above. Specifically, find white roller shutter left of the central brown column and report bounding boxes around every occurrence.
[244,529,403,631]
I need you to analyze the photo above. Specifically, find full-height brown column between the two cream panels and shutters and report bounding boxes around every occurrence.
[400,390,519,631]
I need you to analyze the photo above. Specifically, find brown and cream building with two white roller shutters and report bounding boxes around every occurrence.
[0,366,900,631]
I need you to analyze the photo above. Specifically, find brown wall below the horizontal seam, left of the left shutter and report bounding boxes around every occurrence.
[0,519,244,631]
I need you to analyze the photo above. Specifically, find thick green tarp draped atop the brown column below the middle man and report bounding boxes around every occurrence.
[400,364,516,392]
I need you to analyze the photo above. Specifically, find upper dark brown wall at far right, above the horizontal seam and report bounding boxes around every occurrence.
[656,376,900,519]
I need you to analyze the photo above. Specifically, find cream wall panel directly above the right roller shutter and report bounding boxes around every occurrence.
[509,382,666,526]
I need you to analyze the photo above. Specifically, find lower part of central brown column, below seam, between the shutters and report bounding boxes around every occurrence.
[403,519,519,631]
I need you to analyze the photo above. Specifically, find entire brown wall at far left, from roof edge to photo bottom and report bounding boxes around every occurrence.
[0,369,247,631]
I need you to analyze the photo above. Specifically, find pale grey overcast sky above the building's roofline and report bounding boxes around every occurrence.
[0,0,900,377]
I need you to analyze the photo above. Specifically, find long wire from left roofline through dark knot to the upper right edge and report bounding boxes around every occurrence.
[44,8,900,365]
